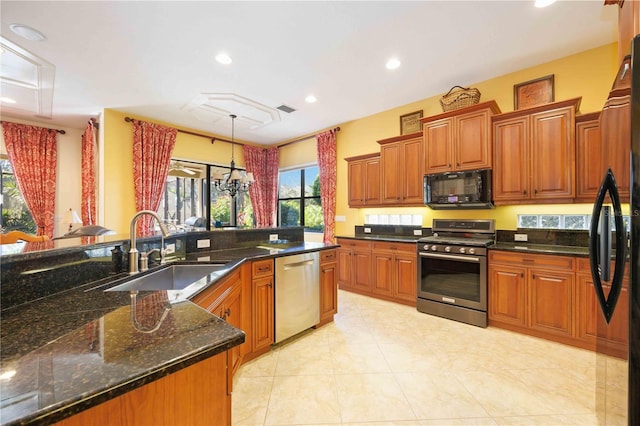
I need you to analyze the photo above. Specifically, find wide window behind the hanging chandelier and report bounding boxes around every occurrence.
[158,160,253,229]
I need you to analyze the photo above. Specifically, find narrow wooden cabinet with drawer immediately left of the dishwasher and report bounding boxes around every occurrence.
[251,259,275,356]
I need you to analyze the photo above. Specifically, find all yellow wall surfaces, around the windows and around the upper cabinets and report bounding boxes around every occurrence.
[102,43,618,235]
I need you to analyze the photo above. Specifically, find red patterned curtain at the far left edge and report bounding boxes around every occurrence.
[2,122,58,238]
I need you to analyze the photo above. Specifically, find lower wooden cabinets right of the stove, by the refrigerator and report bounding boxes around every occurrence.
[488,250,629,358]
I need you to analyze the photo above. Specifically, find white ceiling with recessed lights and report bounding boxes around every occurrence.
[0,0,617,144]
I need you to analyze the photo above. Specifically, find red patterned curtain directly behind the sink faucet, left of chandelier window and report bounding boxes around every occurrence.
[133,120,178,236]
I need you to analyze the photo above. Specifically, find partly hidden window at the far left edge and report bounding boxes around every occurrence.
[0,158,36,234]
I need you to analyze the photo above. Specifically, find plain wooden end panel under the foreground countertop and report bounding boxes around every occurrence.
[55,352,231,426]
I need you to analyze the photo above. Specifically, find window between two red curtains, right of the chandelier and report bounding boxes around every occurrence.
[278,166,324,232]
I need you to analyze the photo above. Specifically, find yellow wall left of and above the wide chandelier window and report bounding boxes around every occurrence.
[101,109,251,234]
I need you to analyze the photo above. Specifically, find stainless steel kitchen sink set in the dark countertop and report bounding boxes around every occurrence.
[105,263,226,291]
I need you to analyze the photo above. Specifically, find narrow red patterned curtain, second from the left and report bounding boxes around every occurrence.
[81,120,96,225]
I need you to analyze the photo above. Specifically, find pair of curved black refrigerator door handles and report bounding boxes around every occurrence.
[589,169,627,324]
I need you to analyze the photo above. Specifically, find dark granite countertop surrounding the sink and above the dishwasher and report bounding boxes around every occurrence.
[0,243,334,425]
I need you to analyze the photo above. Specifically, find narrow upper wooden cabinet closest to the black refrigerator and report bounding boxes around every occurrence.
[576,112,604,203]
